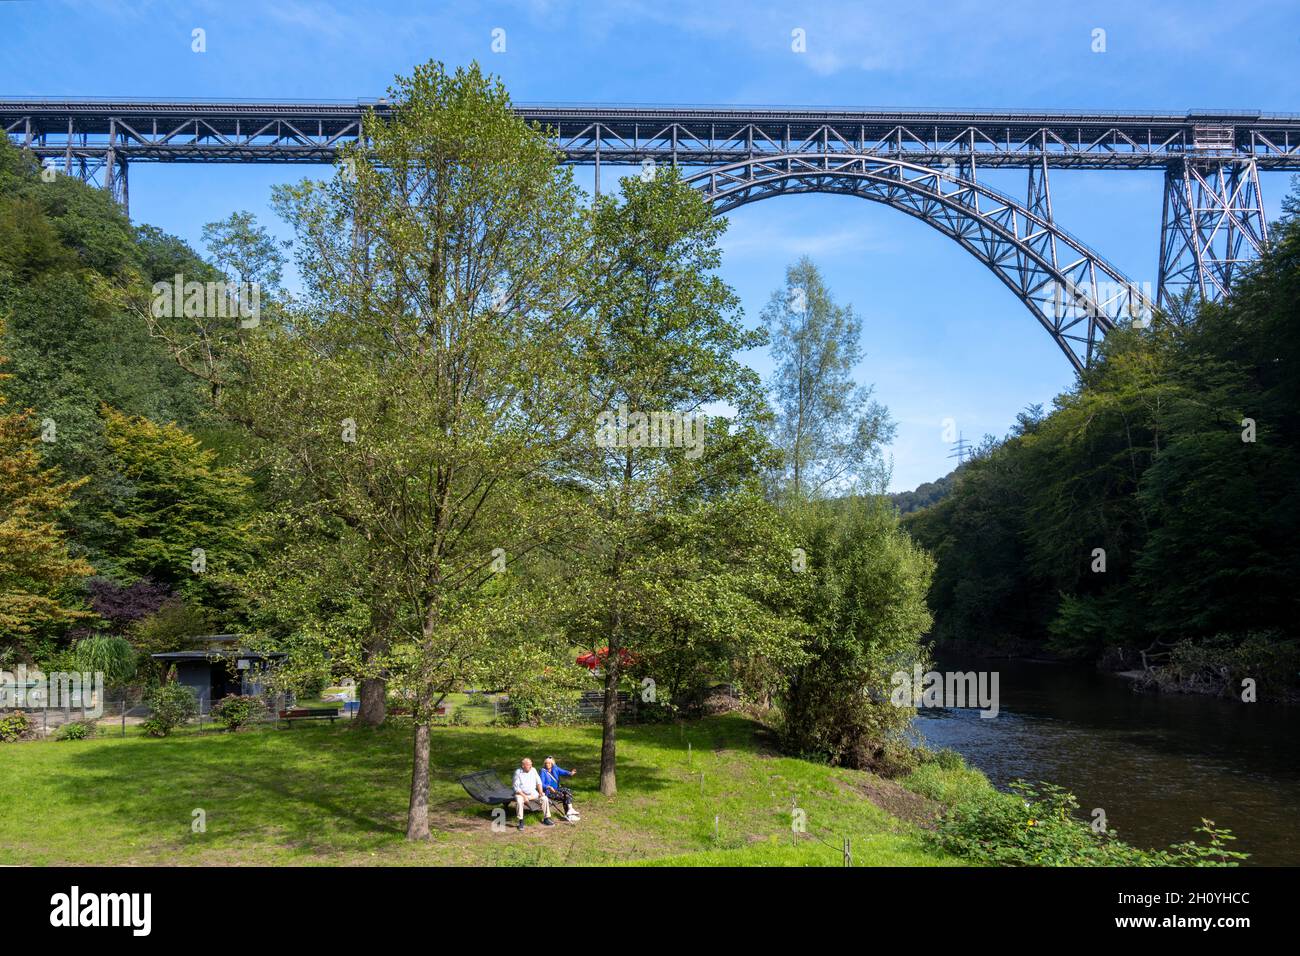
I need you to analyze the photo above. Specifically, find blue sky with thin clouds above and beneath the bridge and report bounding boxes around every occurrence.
[0,0,1300,489]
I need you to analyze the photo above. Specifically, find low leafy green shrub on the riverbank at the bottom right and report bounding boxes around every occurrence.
[933,780,1247,866]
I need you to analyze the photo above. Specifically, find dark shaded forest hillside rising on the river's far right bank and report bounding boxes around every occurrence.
[906,188,1300,692]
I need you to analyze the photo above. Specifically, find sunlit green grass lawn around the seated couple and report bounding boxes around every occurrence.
[0,715,957,866]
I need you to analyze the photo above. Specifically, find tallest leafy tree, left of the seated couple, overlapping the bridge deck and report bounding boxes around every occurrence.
[235,62,590,839]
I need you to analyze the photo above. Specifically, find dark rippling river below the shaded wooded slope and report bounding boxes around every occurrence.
[917,653,1300,866]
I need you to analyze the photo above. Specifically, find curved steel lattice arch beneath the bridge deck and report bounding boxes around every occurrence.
[685,152,1152,371]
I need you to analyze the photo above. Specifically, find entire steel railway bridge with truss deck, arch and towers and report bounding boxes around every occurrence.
[0,99,1300,368]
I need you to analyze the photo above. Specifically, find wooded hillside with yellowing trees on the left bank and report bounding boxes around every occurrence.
[0,139,246,667]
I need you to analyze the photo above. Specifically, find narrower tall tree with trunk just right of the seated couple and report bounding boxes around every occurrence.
[577,172,788,795]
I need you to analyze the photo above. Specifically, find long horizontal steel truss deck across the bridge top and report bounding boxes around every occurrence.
[0,99,1300,170]
